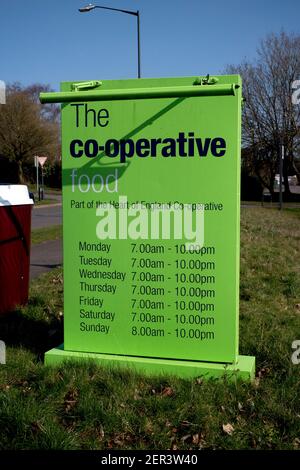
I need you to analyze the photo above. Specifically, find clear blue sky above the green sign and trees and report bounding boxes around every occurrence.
[0,0,300,90]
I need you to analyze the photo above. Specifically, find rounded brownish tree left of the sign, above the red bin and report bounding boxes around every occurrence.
[0,84,59,183]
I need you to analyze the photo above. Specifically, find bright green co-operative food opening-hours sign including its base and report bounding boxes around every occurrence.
[42,76,254,377]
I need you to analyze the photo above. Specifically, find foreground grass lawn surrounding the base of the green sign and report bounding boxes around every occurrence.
[0,208,300,450]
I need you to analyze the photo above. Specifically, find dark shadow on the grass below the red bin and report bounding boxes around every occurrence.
[0,309,63,360]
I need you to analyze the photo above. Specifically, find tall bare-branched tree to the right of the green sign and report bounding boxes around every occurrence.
[228,32,300,193]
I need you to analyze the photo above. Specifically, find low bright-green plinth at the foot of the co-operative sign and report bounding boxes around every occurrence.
[45,345,255,380]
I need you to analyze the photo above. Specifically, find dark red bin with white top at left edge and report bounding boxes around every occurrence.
[0,185,33,315]
